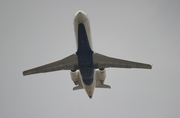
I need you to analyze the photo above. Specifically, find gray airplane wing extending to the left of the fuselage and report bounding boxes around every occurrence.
[23,54,78,76]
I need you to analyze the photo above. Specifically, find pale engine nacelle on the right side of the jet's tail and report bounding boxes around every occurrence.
[95,69,106,81]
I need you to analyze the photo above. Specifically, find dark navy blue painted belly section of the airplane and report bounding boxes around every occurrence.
[76,23,94,85]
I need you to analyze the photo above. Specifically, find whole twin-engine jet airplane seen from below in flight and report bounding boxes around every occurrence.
[23,11,152,99]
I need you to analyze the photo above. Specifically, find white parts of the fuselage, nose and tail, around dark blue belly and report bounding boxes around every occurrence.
[74,11,96,98]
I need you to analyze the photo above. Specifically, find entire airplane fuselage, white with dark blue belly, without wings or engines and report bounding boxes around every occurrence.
[74,11,95,98]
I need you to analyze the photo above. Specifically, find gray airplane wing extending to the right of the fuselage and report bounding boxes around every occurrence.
[93,53,152,69]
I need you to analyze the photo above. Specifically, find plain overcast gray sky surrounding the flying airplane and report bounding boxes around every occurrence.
[0,0,180,118]
